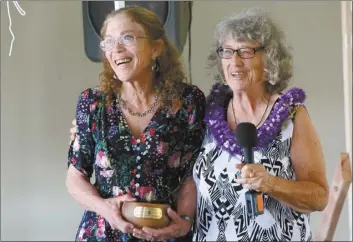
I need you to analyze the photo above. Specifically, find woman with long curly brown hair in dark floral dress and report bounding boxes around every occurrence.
[66,7,205,241]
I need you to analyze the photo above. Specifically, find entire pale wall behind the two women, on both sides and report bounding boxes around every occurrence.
[1,1,349,241]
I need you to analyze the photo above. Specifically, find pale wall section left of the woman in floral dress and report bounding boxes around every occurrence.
[1,1,100,241]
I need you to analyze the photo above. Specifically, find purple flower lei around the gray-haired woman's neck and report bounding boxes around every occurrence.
[204,83,306,156]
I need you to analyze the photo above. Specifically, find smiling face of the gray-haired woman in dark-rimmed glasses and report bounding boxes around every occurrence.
[221,38,264,91]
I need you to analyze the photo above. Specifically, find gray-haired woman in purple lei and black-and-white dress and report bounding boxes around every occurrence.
[193,9,328,241]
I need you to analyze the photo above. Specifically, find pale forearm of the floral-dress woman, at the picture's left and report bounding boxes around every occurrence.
[66,166,107,215]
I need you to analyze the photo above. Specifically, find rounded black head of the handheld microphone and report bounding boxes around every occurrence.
[235,123,257,148]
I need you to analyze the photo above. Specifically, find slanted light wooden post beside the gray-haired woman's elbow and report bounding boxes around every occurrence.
[314,153,352,241]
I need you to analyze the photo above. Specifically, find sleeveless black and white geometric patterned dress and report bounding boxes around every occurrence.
[193,84,312,241]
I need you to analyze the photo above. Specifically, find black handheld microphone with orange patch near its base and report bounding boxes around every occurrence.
[235,123,264,218]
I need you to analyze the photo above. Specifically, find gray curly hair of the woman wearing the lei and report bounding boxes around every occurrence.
[207,8,293,93]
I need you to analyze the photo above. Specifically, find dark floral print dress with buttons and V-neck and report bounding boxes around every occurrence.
[68,84,205,241]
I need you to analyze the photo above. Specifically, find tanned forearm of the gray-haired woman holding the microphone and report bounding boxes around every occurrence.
[267,176,328,213]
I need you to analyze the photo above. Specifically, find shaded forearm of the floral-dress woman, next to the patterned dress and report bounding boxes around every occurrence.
[177,176,196,217]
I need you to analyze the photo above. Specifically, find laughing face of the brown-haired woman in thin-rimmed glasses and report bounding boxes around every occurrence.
[104,14,159,82]
